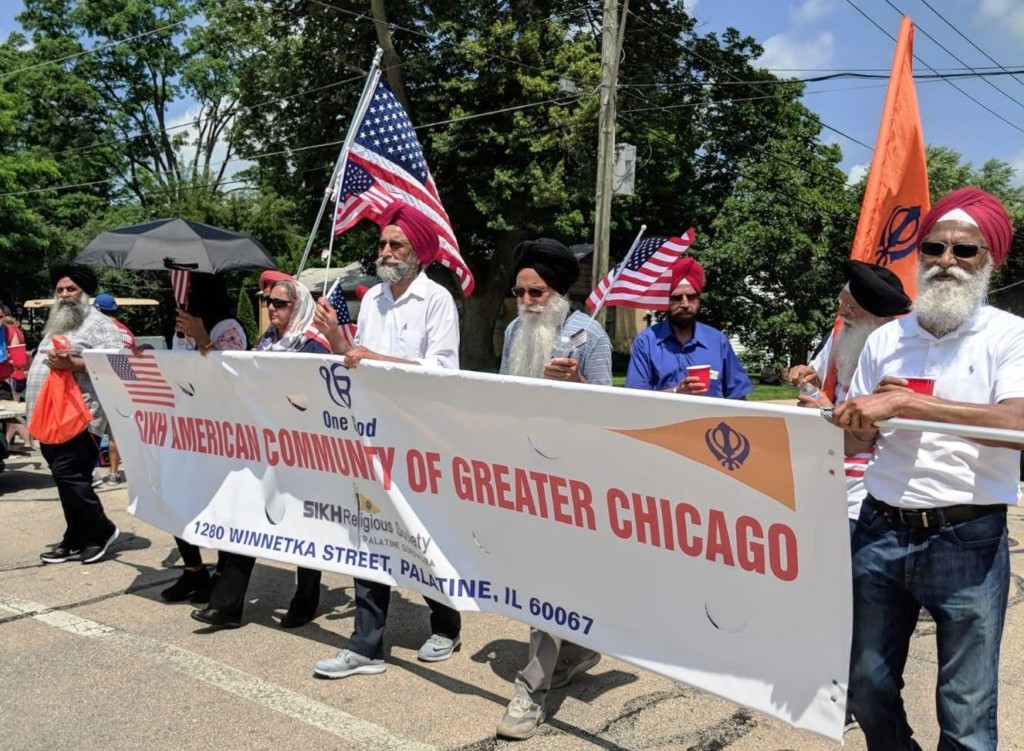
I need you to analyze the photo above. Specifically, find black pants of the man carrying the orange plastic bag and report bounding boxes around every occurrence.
[39,430,114,550]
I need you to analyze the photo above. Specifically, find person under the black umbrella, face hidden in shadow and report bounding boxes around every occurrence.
[160,273,246,602]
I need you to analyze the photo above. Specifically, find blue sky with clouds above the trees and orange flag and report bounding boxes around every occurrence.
[0,0,1024,184]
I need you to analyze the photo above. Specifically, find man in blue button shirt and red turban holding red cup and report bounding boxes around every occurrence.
[626,255,754,399]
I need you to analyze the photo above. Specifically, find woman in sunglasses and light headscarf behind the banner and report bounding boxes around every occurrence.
[191,272,329,628]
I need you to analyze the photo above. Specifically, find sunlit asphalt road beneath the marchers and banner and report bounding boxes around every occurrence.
[0,454,1024,751]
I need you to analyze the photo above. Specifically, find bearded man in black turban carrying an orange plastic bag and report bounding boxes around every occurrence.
[26,263,123,564]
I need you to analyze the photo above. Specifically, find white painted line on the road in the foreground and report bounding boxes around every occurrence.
[0,595,435,751]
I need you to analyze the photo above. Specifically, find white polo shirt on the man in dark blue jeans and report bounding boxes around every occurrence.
[850,306,1024,508]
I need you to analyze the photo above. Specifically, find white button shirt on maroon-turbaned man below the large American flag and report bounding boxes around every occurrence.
[355,272,459,369]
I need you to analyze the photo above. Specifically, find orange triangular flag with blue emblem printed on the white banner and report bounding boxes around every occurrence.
[613,417,797,511]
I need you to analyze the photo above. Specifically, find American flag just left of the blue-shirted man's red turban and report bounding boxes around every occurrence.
[587,227,694,310]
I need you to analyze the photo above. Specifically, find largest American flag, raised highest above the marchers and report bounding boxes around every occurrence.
[334,80,475,296]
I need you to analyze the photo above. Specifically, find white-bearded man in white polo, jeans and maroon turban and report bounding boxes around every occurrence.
[835,187,1024,751]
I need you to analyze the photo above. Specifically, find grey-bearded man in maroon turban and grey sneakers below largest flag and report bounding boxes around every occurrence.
[313,201,462,678]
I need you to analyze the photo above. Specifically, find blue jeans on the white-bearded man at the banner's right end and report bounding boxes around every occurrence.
[850,503,1010,751]
